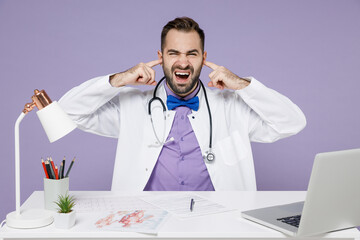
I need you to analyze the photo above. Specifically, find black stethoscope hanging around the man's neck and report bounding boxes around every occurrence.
[148,76,215,162]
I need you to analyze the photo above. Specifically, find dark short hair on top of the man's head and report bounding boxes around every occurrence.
[161,17,205,52]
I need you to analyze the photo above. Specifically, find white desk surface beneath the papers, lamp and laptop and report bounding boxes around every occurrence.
[0,191,360,239]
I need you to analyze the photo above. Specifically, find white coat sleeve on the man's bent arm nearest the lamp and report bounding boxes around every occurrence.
[59,75,120,138]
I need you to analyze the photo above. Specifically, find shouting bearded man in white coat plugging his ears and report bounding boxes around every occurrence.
[59,17,306,191]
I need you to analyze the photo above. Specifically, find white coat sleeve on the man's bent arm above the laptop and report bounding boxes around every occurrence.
[236,78,306,142]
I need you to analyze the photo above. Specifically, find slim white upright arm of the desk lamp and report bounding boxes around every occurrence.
[15,112,26,215]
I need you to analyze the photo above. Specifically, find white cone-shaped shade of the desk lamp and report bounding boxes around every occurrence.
[36,101,76,142]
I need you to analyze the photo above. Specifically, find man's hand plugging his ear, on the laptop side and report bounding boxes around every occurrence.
[204,61,250,90]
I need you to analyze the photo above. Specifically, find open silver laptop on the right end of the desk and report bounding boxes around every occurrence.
[242,149,360,236]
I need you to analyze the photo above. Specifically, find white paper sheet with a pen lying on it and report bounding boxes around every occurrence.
[142,193,232,218]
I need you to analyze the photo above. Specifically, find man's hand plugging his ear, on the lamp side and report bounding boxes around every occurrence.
[110,59,162,87]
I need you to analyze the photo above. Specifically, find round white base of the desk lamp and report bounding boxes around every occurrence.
[6,209,54,228]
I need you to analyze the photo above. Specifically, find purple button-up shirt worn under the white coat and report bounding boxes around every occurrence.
[144,84,215,191]
